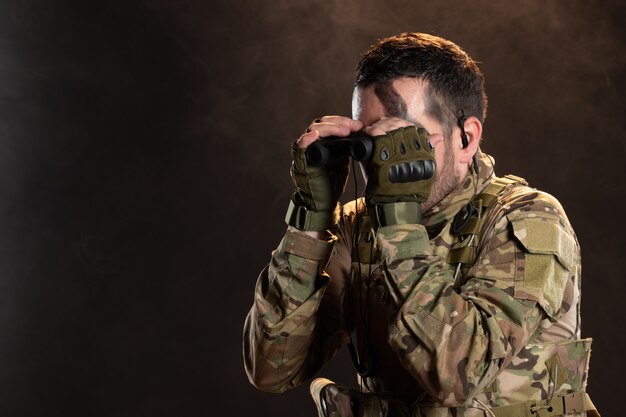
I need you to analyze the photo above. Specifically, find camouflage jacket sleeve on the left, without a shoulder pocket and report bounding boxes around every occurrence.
[243,227,349,392]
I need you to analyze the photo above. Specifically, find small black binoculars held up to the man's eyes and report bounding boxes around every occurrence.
[305,133,374,166]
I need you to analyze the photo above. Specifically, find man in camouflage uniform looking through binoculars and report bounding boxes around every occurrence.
[244,33,598,417]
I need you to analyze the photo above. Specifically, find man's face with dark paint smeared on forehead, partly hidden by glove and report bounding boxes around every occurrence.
[352,77,461,211]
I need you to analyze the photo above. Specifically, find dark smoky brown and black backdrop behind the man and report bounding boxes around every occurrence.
[0,0,626,417]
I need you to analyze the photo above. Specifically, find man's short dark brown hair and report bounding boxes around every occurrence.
[355,33,487,134]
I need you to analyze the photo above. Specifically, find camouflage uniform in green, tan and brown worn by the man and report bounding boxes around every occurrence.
[244,153,595,417]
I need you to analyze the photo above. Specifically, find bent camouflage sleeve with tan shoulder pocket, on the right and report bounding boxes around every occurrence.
[377,194,577,407]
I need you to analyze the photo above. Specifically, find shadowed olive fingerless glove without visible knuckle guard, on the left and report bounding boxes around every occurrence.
[285,144,348,231]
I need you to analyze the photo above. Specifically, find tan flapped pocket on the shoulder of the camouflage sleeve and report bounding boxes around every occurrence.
[509,214,577,320]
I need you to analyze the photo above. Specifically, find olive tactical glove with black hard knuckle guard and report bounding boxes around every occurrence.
[365,126,435,226]
